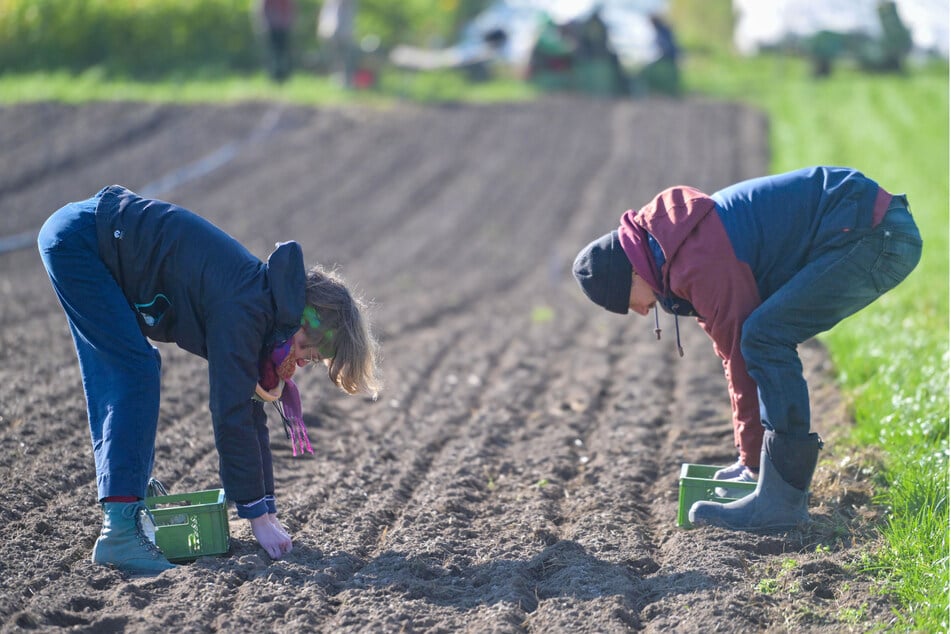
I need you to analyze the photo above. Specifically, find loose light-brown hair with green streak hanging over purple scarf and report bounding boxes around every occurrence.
[303,264,383,398]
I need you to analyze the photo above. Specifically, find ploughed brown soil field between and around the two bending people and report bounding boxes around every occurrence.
[0,99,891,633]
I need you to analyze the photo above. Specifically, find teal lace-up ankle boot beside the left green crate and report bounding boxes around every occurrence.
[92,502,175,574]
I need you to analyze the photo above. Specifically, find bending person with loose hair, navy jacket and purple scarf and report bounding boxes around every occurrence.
[38,185,379,574]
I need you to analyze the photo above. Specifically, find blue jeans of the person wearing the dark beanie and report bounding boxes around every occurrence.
[740,195,921,435]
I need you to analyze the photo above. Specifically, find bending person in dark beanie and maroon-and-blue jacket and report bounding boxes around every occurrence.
[574,167,921,531]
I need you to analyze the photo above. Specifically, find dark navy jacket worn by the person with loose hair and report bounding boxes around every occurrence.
[96,185,306,517]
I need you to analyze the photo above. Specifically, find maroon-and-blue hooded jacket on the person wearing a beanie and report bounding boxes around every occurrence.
[619,167,891,466]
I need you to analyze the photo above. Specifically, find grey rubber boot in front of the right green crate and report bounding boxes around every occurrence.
[688,430,822,531]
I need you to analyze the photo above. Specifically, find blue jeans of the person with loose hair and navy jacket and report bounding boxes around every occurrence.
[37,195,162,500]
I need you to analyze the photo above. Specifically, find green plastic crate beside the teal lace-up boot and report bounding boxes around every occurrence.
[145,489,231,562]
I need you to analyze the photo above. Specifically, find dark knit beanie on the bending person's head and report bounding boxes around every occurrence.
[572,231,633,315]
